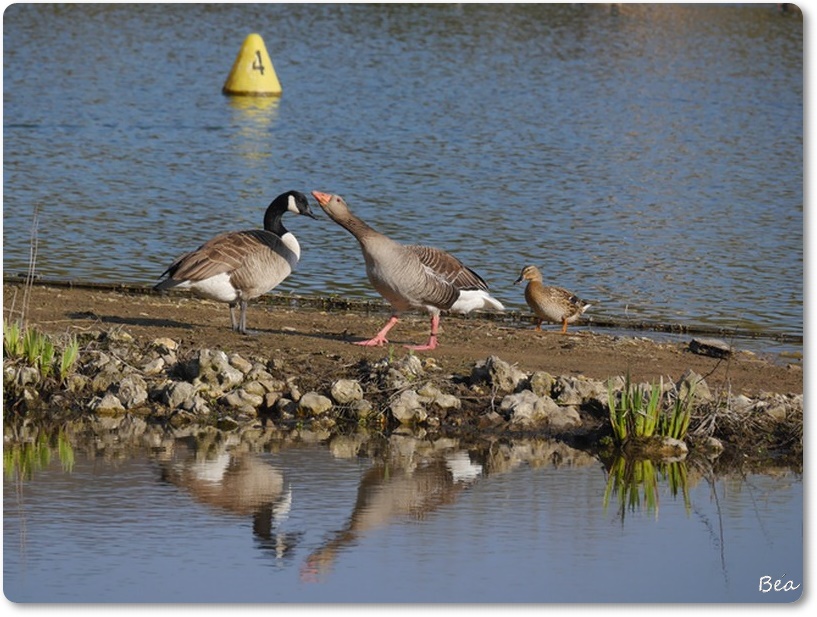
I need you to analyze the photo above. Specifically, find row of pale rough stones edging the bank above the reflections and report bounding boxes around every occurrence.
[5,331,803,454]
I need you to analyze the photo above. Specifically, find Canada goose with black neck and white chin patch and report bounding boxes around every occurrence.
[154,191,317,334]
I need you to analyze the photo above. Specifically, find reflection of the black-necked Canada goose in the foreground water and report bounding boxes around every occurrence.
[162,452,300,559]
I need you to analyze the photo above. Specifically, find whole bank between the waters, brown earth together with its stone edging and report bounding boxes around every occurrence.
[4,285,803,464]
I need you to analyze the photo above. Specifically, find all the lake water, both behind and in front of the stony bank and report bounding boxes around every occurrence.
[3,4,804,603]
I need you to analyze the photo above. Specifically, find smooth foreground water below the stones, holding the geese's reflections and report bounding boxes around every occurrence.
[3,426,804,603]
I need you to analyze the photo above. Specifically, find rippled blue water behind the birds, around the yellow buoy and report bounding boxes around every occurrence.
[3,4,803,336]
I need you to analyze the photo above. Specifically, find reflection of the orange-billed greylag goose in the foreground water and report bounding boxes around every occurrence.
[301,450,483,582]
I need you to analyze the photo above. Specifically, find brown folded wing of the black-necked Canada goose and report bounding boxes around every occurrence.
[165,229,291,281]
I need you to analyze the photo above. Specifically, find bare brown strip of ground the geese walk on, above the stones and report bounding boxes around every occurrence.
[3,282,803,396]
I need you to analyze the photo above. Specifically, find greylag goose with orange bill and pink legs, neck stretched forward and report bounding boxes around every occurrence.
[312,191,505,351]
